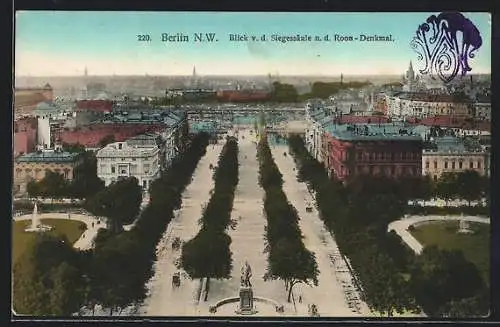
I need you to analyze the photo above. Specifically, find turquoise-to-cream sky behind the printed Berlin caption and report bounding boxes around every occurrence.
[14,11,491,76]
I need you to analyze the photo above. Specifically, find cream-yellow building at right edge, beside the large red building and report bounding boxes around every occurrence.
[422,136,490,181]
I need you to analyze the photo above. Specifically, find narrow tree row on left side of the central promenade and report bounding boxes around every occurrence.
[181,137,239,301]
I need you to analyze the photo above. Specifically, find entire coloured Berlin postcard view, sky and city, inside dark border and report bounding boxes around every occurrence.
[11,11,491,319]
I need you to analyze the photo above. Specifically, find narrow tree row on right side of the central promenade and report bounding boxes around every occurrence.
[257,136,319,302]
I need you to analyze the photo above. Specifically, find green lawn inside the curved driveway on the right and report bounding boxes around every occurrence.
[411,221,490,284]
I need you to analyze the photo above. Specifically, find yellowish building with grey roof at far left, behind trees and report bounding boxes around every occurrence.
[14,150,83,193]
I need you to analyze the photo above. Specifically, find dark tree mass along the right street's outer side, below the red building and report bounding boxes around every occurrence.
[289,136,488,316]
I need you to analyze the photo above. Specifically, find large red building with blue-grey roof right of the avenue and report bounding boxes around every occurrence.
[322,124,423,181]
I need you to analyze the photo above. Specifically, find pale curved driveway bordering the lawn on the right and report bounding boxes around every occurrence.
[387,216,490,254]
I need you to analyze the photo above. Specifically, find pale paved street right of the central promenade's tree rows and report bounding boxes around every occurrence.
[271,145,370,317]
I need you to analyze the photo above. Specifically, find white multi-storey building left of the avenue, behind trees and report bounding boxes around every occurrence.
[96,142,161,190]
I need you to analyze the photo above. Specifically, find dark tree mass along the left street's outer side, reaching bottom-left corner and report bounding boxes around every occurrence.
[13,134,209,316]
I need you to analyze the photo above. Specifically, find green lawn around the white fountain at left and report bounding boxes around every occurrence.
[12,218,85,262]
